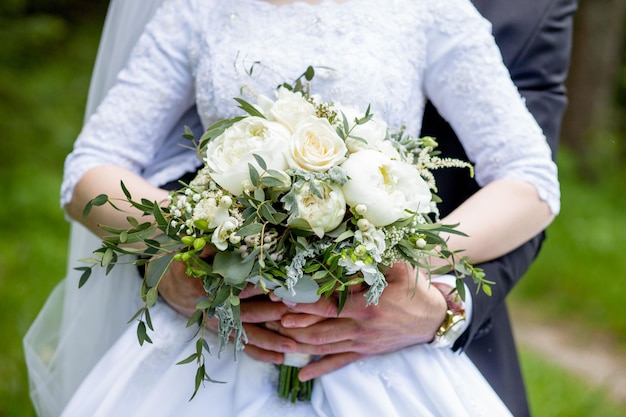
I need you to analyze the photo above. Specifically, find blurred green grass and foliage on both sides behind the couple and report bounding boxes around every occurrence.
[0,0,626,417]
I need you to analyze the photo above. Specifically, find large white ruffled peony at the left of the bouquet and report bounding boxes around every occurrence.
[205,116,290,195]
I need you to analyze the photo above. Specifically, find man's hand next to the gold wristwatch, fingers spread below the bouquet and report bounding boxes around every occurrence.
[268,264,447,381]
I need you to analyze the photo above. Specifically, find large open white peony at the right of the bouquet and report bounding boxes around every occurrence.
[341,150,432,227]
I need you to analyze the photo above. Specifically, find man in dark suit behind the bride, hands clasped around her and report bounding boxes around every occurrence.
[160,0,577,416]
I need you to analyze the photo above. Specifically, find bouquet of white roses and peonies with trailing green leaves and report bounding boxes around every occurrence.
[78,67,489,401]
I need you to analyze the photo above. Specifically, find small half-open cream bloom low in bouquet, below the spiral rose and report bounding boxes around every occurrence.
[285,181,346,238]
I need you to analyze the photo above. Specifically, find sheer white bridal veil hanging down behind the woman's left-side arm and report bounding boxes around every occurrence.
[24,0,166,417]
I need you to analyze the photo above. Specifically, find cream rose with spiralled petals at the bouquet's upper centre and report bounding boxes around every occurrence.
[287,116,348,172]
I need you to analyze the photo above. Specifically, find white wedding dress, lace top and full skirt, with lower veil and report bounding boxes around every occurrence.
[25,0,559,417]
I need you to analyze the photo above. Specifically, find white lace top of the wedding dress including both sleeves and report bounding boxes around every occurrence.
[61,0,559,213]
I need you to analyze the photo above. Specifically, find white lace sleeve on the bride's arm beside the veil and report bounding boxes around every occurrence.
[61,0,197,205]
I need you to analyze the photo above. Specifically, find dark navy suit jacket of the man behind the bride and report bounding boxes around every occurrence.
[422,0,577,416]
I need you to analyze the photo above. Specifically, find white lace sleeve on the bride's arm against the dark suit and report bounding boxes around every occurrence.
[424,0,560,214]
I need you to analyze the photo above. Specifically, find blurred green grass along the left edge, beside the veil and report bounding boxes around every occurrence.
[0,10,104,417]
